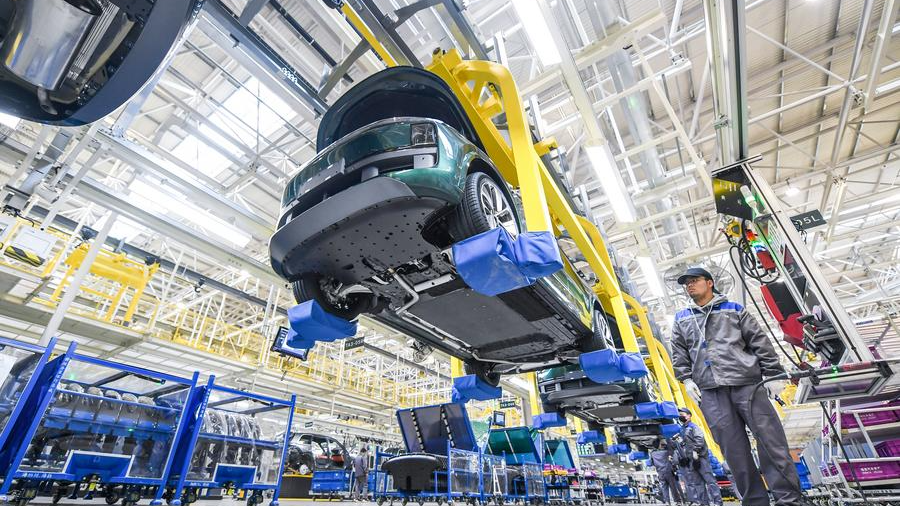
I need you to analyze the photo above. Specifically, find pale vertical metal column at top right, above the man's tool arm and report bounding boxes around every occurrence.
[703,0,749,165]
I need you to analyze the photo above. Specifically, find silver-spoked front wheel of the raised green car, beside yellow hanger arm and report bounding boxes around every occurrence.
[451,172,519,241]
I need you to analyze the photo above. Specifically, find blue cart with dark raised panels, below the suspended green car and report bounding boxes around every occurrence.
[374,403,483,505]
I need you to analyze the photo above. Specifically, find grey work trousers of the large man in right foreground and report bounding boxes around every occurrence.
[700,385,801,506]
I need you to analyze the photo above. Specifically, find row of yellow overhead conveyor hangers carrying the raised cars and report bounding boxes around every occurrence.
[341,3,722,458]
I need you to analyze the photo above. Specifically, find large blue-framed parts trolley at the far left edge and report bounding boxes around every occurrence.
[0,343,198,506]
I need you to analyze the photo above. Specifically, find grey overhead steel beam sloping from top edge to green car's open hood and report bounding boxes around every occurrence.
[199,0,328,117]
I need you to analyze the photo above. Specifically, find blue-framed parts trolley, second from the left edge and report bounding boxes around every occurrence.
[165,376,296,506]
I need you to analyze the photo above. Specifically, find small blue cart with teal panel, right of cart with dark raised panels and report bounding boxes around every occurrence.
[484,427,544,504]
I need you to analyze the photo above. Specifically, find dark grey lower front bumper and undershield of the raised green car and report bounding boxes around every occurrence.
[269,176,446,283]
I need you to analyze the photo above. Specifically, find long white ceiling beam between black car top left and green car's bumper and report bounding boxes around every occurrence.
[97,129,274,240]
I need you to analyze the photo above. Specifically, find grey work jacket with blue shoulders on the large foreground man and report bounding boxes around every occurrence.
[672,295,784,390]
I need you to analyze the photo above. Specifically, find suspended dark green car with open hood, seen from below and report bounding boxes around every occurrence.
[270,67,602,382]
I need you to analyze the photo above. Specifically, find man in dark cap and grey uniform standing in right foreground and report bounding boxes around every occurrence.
[672,267,803,506]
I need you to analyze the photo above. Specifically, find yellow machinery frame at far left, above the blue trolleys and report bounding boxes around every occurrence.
[50,243,159,325]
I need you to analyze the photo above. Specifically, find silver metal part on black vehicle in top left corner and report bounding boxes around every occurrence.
[0,0,103,94]
